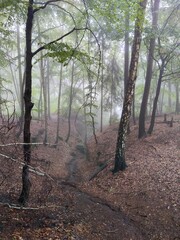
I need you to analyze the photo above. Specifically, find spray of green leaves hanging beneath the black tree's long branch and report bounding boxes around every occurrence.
[44,42,92,66]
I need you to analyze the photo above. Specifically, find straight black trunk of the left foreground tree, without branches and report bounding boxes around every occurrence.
[19,0,33,205]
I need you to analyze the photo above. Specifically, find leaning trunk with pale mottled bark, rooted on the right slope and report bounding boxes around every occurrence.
[113,0,147,173]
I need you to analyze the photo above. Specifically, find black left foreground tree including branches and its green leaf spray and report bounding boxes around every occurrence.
[19,0,92,204]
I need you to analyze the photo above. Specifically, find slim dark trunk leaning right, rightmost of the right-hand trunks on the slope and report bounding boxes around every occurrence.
[148,61,165,134]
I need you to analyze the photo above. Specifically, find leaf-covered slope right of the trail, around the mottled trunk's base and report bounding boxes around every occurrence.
[79,116,180,240]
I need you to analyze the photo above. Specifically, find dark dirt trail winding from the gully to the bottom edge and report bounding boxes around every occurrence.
[59,133,148,240]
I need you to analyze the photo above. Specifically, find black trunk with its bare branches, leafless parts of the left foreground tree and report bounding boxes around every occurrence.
[19,0,90,205]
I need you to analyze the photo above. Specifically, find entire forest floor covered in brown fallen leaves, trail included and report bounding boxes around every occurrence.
[0,116,180,240]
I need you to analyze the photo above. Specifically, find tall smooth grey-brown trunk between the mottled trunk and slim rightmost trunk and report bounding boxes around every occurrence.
[138,0,160,138]
